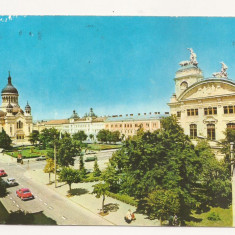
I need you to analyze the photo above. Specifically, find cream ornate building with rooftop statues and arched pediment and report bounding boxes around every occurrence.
[168,49,235,153]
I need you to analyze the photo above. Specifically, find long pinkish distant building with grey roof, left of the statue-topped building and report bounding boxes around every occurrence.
[105,112,169,139]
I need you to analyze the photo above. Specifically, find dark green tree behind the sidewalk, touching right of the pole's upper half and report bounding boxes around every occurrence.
[57,137,81,167]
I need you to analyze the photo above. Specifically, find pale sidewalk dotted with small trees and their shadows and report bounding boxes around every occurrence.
[25,169,160,226]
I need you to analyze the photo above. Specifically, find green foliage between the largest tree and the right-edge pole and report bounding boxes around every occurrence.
[195,140,231,209]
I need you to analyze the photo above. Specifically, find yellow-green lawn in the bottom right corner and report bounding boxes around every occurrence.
[186,206,232,227]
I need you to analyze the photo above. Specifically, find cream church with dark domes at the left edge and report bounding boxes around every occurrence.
[0,72,33,145]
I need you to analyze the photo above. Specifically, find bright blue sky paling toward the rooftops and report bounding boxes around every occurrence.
[0,16,235,120]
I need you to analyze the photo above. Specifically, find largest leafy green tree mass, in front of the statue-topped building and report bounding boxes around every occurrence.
[104,116,201,224]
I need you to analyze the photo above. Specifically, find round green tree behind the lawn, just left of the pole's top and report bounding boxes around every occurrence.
[39,128,60,149]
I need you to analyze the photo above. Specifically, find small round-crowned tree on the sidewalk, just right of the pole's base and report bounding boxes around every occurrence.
[59,167,81,192]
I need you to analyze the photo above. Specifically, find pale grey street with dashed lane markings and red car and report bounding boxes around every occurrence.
[0,154,113,225]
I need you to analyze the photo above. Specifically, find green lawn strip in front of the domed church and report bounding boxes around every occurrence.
[6,147,49,158]
